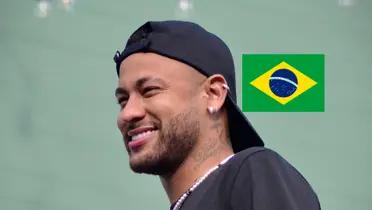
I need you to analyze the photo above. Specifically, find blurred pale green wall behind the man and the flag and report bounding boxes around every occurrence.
[0,0,372,210]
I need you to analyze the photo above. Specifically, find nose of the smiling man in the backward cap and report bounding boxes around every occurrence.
[118,96,146,128]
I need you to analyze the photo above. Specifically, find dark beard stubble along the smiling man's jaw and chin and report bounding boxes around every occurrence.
[130,108,200,176]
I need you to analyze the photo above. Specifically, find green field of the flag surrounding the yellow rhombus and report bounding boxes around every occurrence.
[241,54,324,112]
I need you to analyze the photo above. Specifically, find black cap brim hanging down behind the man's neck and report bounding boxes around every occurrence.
[226,95,264,153]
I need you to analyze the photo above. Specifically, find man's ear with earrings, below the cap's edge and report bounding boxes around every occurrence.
[205,74,229,114]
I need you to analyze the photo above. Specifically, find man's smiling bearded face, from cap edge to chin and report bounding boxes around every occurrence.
[115,53,205,175]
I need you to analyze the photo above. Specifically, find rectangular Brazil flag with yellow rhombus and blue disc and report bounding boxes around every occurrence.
[242,54,324,112]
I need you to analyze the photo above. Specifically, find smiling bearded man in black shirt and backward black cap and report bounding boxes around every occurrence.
[114,21,320,210]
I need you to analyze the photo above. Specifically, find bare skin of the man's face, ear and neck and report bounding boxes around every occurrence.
[115,53,233,203]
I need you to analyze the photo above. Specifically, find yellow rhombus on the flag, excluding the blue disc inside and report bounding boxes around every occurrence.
[250,61,317,105]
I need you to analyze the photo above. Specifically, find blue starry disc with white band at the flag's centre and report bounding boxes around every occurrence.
[269,69,298,97]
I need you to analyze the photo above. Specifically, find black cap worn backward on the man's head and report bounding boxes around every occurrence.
[114,21,264,152]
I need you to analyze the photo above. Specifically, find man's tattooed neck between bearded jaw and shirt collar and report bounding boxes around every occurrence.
[160,141,233,203]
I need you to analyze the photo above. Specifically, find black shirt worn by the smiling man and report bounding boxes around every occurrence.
[171,147,320,210]
